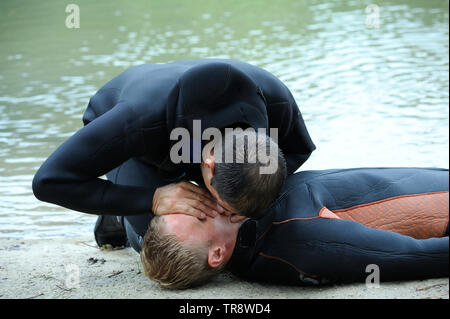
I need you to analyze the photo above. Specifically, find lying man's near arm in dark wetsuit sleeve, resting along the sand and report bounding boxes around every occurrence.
[246,218,449,285]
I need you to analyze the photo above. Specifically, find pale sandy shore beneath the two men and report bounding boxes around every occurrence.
[0,236,449,299]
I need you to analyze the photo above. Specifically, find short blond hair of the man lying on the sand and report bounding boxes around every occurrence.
[141,216,225,289]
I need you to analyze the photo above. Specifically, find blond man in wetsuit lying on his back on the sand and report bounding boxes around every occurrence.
[141,168,449,288]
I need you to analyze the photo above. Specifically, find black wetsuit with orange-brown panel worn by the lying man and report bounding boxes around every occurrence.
[228,168,449,285]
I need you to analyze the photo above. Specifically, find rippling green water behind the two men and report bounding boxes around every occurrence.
[0,0,449,238]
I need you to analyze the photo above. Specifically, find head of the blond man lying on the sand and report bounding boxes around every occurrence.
[141,214,242,288]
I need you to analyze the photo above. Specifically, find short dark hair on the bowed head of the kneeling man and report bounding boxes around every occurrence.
[211,130,286,217]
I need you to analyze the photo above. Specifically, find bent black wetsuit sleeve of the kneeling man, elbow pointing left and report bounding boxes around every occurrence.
[33,103,155,216]
